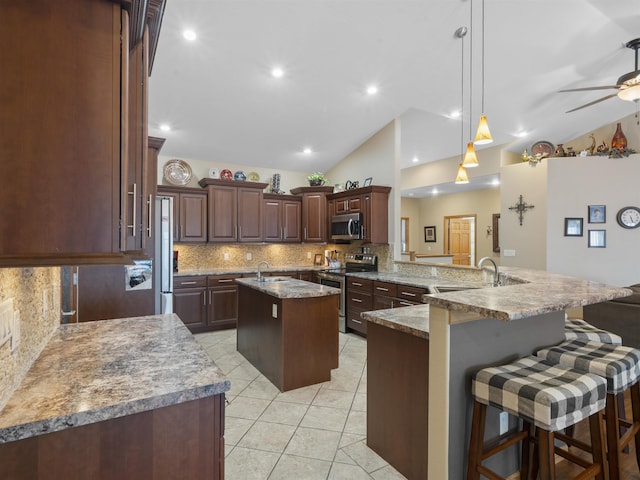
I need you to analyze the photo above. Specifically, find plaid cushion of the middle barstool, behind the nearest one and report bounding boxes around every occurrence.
[536,340,640,393]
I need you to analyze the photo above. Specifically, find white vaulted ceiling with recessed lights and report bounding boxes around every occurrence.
[149,0,640,195]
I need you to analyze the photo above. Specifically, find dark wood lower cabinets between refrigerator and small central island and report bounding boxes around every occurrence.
[173,275,239,333]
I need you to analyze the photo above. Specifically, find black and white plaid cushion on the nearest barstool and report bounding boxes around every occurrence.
[471,356,607,432]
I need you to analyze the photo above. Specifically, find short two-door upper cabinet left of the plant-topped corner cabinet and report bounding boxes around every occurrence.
[262,193,302,243]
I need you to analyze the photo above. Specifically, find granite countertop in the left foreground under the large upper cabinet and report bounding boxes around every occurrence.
[0,314,231,443]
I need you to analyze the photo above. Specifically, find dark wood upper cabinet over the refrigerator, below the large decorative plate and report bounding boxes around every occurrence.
[158,185,208,243]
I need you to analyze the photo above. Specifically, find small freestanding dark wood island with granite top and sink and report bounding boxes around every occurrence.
[236,277,340,392]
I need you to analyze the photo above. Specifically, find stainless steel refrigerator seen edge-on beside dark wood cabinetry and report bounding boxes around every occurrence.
[154,196,174,314]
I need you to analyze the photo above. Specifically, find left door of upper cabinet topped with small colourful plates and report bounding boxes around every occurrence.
[208,186,238,242]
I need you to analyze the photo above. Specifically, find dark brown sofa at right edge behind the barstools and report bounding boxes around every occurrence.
[583,283,640,348]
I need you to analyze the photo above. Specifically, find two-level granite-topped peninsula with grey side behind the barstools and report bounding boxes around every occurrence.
[357,262,631,479]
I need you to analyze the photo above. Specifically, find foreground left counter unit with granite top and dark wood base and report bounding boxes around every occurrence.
[0,314,231,480]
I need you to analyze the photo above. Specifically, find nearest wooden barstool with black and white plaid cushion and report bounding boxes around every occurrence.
[467,356,606,480]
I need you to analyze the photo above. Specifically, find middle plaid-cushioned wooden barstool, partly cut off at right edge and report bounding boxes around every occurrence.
[537,340,640,480]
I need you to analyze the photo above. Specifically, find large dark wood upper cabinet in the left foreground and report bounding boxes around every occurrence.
[0,0,164,266]
